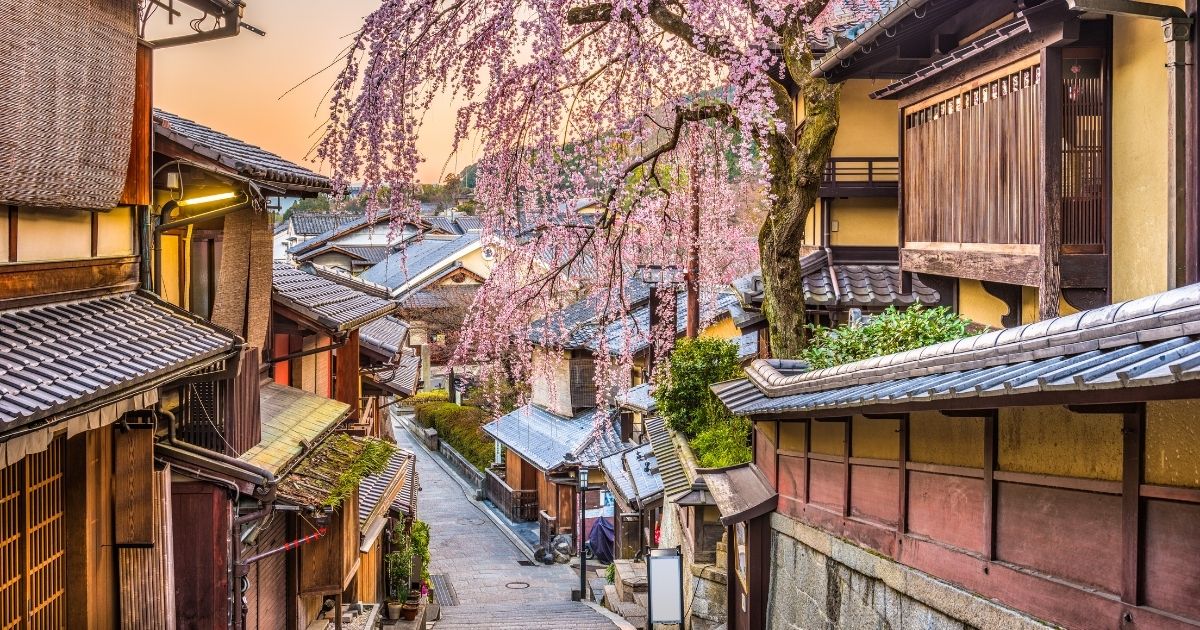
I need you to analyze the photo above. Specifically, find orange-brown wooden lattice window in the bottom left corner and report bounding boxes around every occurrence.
[0,438,66,630]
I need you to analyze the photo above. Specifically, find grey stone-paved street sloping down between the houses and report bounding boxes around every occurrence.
[395,415,619,630]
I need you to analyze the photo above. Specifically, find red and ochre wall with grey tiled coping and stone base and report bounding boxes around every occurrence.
[713,284,1200,628]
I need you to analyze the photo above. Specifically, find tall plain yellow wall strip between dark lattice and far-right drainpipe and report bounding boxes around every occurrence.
[1112,10,1183,301]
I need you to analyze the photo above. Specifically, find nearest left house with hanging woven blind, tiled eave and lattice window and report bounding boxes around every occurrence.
[0,0,270,628]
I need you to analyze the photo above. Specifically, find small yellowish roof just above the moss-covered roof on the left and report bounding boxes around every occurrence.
[240,383,350,473]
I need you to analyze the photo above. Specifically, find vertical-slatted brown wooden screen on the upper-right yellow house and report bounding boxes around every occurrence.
[904,58,1043,244]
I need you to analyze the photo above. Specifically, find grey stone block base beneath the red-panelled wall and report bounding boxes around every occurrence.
[767,514,1046,630]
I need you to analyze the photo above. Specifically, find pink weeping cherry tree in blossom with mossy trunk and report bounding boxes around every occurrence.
[319,0,878,379]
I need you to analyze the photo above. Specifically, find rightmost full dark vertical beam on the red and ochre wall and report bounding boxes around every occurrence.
[1121,406,1146,606]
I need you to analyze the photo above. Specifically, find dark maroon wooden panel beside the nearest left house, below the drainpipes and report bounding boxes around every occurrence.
[170,484,232,630]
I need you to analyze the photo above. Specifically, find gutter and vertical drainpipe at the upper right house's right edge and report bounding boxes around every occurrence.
[1067,0,1194,284]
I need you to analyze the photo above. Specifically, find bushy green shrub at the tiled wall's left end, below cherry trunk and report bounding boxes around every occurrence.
[654,337,751,468]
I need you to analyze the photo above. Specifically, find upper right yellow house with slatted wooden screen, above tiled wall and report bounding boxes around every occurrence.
[814,0,1200,328]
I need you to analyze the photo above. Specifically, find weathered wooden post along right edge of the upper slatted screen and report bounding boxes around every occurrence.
[1038,48,1062,320]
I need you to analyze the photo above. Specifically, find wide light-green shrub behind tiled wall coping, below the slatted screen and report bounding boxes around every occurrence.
[800,305,971,370]
